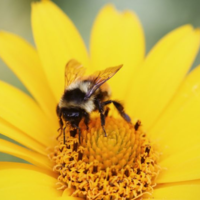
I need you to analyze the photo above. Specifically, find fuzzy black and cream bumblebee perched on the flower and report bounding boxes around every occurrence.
[56,60,131,144]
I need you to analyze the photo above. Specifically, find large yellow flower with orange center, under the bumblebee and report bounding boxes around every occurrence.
[0,1,200,200]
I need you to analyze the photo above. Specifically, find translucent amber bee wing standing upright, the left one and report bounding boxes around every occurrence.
[65,59,85,88]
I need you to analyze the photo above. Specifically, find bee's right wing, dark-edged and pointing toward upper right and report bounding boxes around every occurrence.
[85,65,122,99]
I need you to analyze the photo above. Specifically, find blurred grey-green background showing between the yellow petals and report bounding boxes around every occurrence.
[0,0,200,161]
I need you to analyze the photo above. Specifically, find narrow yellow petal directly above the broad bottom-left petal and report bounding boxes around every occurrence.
[0,139,52,170]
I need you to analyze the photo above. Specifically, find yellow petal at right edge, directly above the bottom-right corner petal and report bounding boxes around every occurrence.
[156,145,200,183]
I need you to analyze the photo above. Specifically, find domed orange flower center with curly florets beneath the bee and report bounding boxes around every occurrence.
[51,117,160,200]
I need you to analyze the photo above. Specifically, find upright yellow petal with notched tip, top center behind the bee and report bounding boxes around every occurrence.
[90,5,145,99]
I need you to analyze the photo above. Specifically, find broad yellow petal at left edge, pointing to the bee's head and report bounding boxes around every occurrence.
[0,81,57,146]
